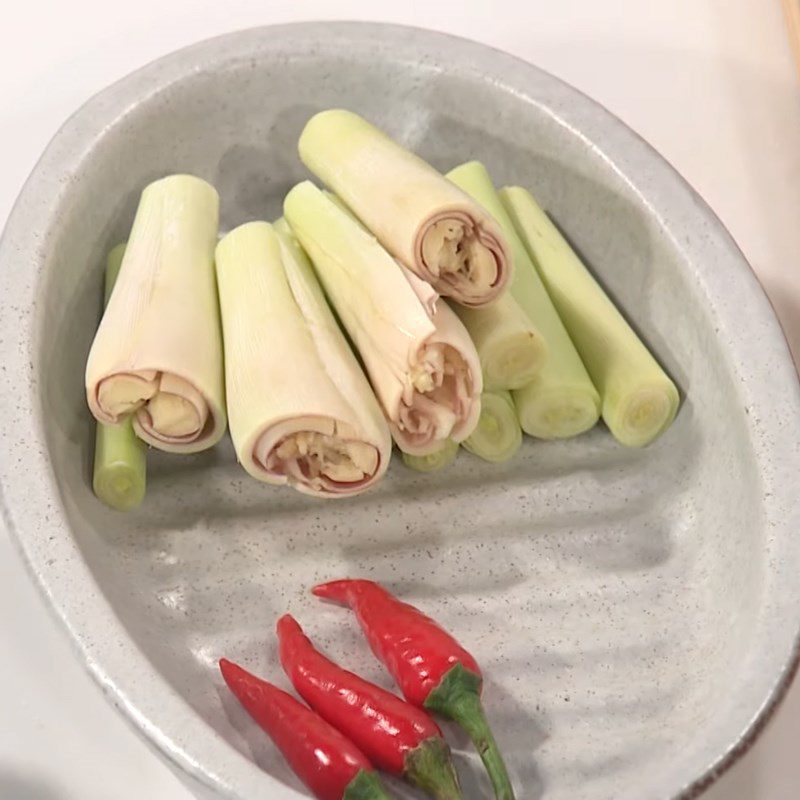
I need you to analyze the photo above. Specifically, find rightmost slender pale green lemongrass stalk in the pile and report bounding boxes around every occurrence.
[500,187,680,447]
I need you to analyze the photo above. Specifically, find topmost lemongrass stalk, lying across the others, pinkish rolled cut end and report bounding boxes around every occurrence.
[298,109,512,306]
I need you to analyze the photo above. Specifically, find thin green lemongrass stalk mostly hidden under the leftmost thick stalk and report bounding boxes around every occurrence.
[92,244,147,511]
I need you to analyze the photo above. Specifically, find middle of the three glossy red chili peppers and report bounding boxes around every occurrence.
[277,614,461,800]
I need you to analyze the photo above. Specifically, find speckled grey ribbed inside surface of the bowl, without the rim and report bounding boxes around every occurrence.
[28,25,784,800]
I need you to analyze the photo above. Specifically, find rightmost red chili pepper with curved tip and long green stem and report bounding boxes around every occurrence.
[313,580,514,800]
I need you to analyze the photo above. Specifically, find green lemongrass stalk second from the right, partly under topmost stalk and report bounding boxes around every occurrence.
[448,161,600,439]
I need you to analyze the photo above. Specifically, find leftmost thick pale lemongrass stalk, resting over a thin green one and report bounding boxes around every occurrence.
[86,175,226,453]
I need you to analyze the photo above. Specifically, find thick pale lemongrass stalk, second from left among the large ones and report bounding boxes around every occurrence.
[212,221,392,497]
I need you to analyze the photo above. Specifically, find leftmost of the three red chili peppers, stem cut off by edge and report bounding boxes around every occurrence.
[219,658,391,800]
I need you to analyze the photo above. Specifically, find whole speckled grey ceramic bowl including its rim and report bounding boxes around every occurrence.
[0,18,800,800]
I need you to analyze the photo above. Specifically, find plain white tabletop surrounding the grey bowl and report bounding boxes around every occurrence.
[0,0,800,800]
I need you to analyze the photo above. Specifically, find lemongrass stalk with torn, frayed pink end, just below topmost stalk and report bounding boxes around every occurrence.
[284,181,483,455]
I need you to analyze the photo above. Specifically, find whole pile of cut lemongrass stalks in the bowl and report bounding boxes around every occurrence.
[86,110,679,510]
